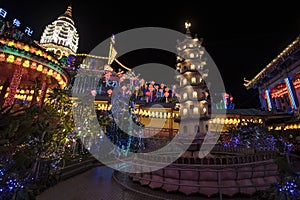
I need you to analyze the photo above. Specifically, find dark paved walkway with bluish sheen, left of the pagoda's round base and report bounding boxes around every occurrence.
[37,166,155,200]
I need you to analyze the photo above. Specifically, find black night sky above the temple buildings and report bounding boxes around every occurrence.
[0,0,300,108]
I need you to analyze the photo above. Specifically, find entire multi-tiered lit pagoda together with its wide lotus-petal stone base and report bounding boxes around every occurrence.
[129,23,278,197]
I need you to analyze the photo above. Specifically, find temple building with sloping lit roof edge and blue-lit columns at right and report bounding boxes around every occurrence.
[244,36,300,113]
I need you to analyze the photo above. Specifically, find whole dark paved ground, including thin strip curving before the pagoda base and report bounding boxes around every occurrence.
[37,166,253,200]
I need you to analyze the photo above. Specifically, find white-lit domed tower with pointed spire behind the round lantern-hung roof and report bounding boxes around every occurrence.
[40,5,79,58]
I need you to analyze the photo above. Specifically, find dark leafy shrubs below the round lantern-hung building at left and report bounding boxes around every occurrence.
[0,88,74,199]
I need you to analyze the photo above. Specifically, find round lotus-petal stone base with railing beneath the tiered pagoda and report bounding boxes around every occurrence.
[130,152,279,197]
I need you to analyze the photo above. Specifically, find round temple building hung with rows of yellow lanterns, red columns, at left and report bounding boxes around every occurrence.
[0,18,70,108]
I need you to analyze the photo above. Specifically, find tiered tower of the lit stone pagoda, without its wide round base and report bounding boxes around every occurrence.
[176,22,210,135]
